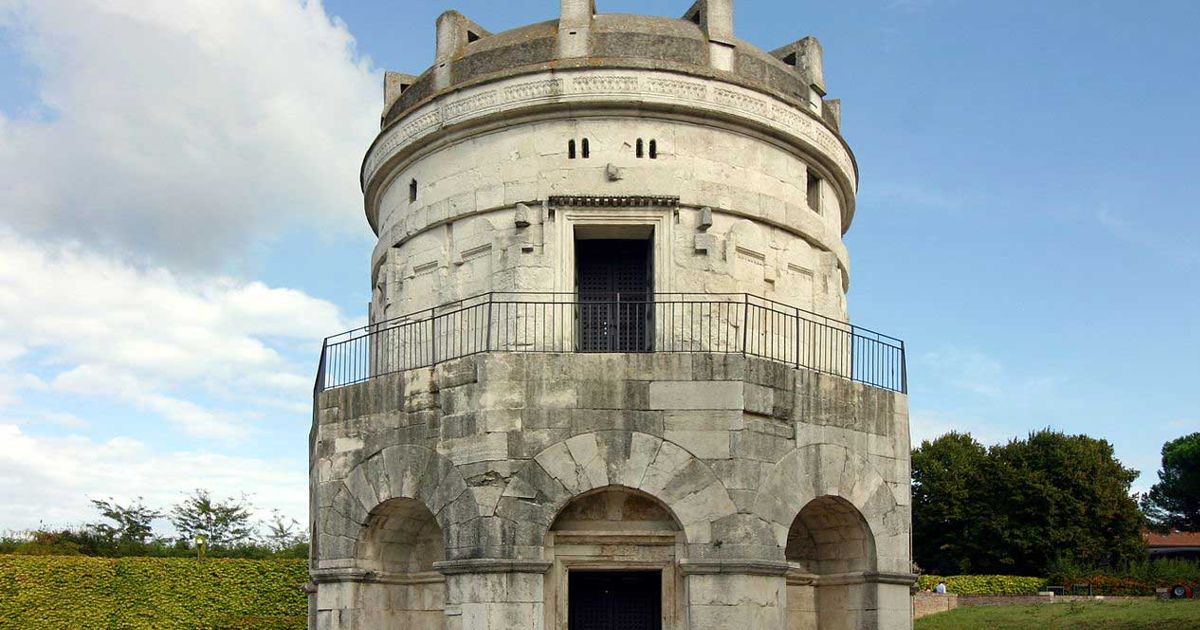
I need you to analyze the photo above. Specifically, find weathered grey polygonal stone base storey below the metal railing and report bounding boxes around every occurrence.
[312,353,912,630]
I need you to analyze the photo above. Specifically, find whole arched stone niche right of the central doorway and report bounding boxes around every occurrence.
[784,496,876,630]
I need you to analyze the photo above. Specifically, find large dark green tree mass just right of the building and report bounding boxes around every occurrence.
[912,430,1145,575]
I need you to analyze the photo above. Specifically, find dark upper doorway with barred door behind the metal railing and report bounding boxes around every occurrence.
[575,239,654,352]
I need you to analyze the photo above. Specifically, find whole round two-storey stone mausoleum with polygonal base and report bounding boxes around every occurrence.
[310,0,913,630]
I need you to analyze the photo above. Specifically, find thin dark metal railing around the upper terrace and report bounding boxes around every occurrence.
[316,293,907,392]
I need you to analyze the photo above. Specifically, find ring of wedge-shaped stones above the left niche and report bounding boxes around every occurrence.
[346,444,479,559]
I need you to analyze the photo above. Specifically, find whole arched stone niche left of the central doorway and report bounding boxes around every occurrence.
[358,498,445,629]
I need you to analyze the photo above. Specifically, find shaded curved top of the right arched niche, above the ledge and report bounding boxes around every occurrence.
[784,494,875,575]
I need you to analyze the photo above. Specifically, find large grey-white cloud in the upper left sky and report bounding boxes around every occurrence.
[0,0,380,267]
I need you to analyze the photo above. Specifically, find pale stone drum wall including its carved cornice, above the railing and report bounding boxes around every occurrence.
[364,59,857,322]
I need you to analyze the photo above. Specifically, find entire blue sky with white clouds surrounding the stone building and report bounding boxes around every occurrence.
[0,0,1200,529]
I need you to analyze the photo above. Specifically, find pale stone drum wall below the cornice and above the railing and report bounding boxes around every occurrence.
[372,107,848,322]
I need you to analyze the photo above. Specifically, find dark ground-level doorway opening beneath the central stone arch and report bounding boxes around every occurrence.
[566,571,662,630]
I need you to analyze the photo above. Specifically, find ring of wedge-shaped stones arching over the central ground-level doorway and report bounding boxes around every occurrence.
[496,431,737,546]
